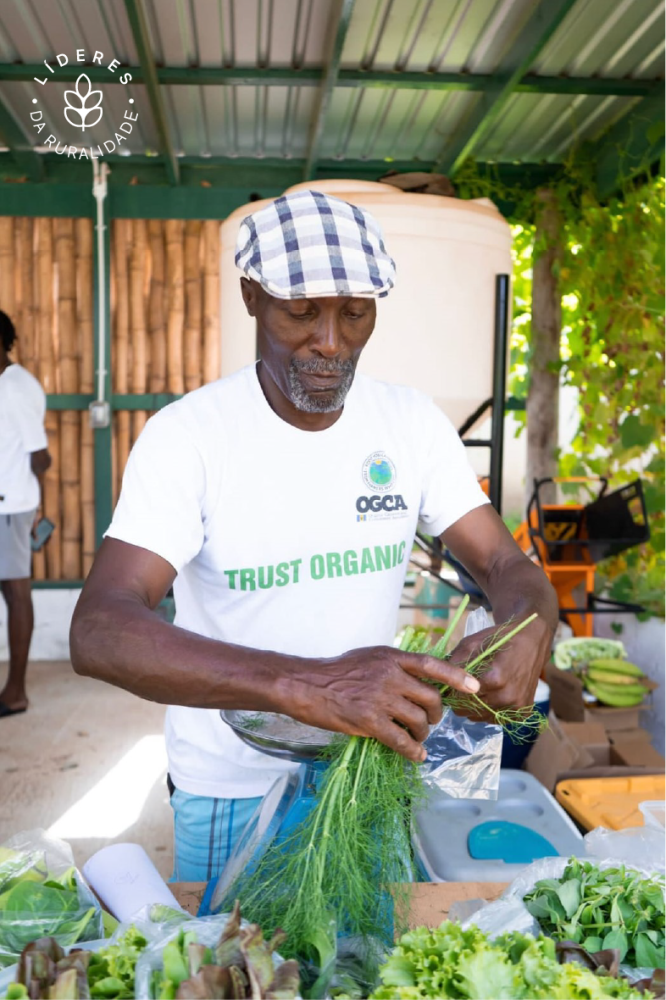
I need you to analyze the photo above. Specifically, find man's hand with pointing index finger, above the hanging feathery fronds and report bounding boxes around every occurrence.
[278,646,479,761]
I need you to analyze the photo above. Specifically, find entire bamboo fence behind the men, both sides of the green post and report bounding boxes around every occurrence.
[0,216,220,580]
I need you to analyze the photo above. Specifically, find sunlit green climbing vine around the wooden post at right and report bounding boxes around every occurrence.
[458,161,666,616]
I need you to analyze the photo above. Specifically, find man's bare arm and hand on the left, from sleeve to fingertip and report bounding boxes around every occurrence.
[70,539,478,760]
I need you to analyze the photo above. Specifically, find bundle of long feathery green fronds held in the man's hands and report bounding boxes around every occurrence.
[231,606,542,996]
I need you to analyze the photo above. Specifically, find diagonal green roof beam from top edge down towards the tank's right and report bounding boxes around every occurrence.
[436,0,576,176]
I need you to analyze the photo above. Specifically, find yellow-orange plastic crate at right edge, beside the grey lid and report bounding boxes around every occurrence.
[555,774,666,830]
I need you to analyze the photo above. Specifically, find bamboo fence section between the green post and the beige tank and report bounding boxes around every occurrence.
[111,219,220,503]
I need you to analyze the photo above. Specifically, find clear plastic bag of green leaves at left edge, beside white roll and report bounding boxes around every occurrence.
[0,830,104,968]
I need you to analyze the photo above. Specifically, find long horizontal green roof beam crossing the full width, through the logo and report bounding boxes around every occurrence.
[0,63,661,97]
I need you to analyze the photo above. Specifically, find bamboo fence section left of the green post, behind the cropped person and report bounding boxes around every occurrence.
[0,216,94,580]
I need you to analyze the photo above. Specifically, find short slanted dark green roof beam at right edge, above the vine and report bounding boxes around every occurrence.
[593,81,666,198]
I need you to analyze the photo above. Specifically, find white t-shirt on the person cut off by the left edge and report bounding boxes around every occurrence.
[0,365,48,514]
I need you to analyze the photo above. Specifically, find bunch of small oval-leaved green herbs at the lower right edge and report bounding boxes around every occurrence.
[525,858,666,969]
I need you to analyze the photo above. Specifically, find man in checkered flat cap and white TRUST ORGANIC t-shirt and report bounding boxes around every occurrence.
[71,191,557,880]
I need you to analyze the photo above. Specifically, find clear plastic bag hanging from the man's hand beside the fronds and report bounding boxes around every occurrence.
[422,608,503,799]
